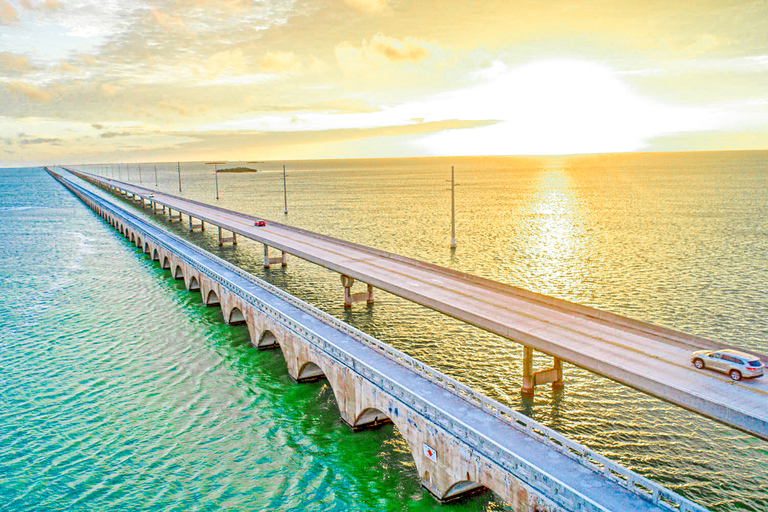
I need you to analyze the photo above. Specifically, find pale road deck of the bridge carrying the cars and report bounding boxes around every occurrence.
[73,171,768,440]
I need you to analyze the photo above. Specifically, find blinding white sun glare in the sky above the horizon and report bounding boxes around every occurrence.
[421,60,703,155]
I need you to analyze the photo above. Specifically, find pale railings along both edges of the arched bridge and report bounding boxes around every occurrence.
[57,170,706,512]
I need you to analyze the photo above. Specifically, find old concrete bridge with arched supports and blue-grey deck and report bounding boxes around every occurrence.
[49,165,705,512]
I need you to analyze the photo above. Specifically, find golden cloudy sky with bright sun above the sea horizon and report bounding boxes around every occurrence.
[0,0,768,166]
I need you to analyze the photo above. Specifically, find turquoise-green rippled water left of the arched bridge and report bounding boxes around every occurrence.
[0,166,499,511]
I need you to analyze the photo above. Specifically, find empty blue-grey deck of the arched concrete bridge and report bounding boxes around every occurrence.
[52,166,704,512]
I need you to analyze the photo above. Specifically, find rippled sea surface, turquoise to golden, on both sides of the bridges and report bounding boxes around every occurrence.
[0,152,768,511]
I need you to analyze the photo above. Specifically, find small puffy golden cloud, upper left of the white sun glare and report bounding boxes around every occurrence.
[336,33,431,73]
